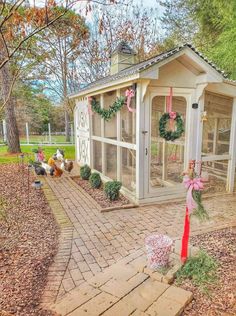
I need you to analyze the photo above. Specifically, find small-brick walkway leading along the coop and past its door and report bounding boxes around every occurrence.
[42,176,236,304]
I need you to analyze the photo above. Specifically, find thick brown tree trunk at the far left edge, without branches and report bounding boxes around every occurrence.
[0,63,21,153]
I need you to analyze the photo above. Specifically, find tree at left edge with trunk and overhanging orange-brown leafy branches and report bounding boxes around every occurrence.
[0,0,114,153]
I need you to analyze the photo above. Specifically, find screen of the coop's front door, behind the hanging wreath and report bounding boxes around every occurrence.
[149,96,187,192]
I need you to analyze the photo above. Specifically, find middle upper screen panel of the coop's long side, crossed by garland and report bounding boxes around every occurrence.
[104,91,117,139]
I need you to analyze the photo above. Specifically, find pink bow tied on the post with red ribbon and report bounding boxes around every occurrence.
[183,176,203,213]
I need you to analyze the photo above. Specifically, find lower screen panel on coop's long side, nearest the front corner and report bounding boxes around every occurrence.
[121,148,136,191]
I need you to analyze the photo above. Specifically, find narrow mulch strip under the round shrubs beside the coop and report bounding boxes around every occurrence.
[74,177,130,208]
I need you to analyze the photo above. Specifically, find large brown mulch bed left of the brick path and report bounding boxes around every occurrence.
[0,164,59,316]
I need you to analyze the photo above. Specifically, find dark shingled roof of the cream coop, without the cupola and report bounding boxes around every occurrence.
[71,44,227,96]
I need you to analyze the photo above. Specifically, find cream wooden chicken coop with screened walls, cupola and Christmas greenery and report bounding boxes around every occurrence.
[70,42,236,203]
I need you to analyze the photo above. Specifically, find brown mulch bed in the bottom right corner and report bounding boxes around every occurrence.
[181,228,236,316]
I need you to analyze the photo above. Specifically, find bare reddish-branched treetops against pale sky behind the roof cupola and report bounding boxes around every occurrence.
[78,0,160,83]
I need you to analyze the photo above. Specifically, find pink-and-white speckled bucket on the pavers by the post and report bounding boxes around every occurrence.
[145,235,173,269]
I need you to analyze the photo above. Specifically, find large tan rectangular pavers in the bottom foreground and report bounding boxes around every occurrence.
[50,250,192,316]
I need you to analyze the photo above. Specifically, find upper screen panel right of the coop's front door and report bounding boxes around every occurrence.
[202,92,233,155]
